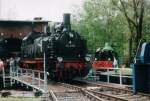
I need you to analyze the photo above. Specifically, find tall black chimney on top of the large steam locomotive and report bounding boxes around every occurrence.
[63,13,71,30]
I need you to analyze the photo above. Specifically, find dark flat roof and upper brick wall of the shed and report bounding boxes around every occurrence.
[0,20,49,39]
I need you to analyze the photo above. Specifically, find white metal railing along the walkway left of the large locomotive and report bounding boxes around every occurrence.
[10,67,47,93]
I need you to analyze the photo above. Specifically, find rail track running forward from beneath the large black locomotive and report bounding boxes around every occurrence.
[49,83,104,101]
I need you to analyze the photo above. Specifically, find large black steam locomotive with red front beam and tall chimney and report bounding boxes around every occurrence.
[21,14,90,80]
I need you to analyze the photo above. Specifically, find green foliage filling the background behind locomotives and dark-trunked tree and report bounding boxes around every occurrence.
[72,0,150,63]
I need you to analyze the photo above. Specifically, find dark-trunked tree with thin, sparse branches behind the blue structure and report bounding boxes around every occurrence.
[112,0,145,61]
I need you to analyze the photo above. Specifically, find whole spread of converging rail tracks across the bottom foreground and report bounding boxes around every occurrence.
[42,81,150,101]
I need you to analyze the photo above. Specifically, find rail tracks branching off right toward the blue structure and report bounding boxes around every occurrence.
[70,81,150,101]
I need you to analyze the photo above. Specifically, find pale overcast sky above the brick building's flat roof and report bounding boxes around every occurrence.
[0,0,84,21]
